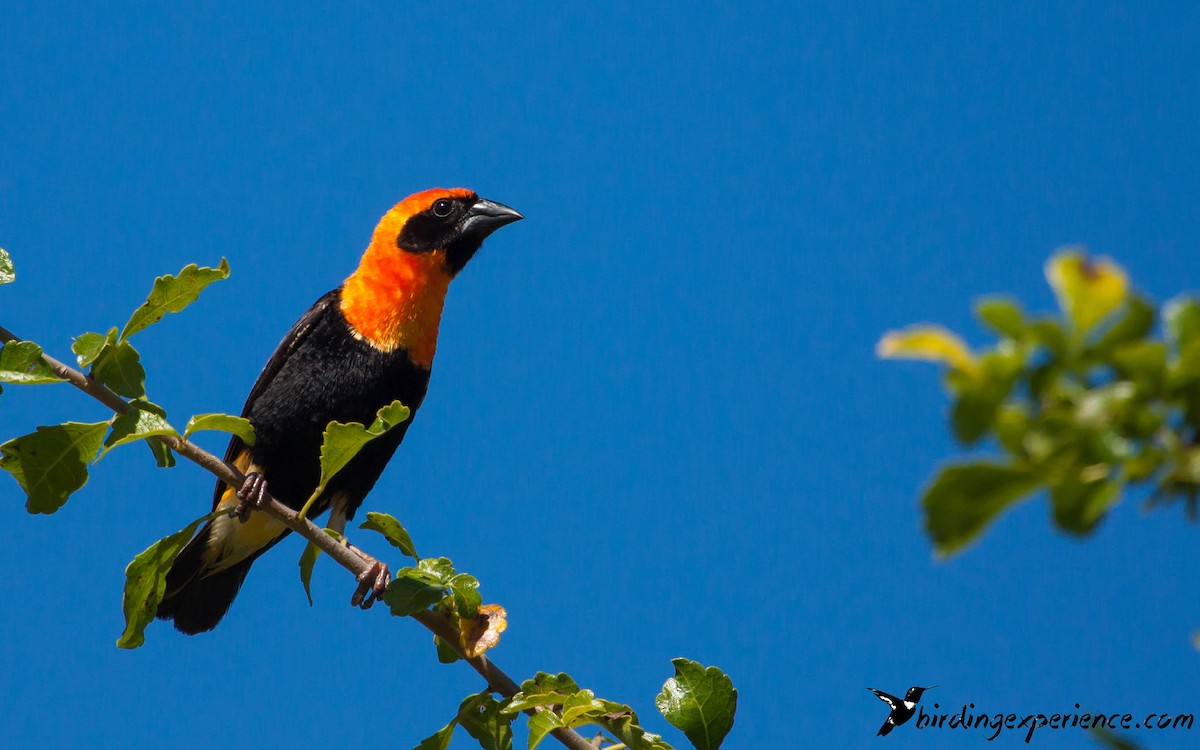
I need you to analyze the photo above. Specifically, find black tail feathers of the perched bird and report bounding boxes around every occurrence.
[157,523,254,635]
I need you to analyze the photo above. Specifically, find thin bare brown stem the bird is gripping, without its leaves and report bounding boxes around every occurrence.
[0,326,592,750]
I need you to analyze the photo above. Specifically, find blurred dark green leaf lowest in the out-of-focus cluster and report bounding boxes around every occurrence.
[923,462,1040,554]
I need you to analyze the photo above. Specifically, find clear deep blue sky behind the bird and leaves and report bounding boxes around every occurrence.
[0,1,1200,750]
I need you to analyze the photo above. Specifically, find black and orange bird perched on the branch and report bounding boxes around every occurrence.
[156,187,524,635]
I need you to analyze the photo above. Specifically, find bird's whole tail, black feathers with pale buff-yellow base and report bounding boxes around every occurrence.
[157,511,287,635]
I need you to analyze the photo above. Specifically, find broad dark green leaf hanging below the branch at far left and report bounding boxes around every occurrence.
[0,422,108,514]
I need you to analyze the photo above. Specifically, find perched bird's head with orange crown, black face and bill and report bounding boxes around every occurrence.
[371,187,524,277]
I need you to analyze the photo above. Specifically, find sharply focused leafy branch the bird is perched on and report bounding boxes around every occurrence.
[0,250,737,750]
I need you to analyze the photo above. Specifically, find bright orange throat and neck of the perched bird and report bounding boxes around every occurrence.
[341,242,450,368]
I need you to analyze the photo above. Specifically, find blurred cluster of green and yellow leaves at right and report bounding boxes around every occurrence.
[877,250,1200,554]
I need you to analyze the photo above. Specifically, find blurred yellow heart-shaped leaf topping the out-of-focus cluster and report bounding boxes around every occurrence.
[1046,250,1129,334]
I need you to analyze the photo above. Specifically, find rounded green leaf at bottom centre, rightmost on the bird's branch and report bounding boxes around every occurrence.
[654,659,738,750]
